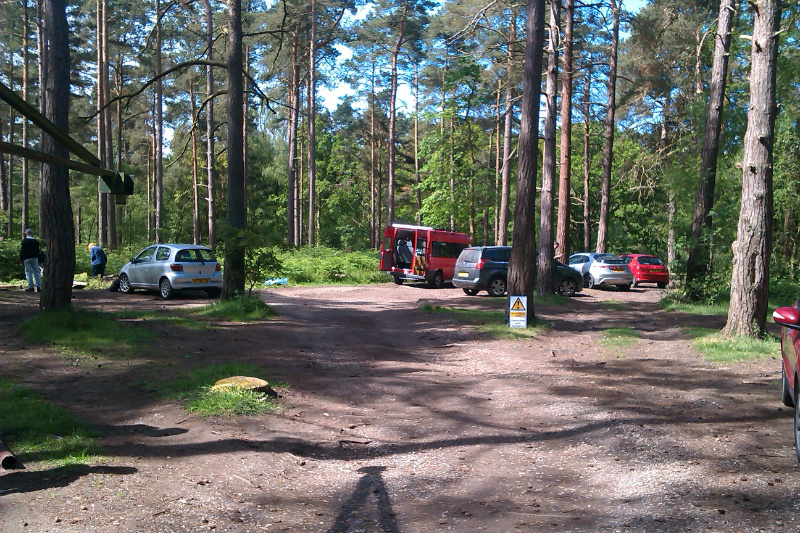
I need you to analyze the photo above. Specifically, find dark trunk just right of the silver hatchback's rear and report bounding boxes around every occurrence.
[222,0,247,300]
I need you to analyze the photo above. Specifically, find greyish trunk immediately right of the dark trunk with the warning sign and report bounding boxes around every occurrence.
[536,0,560,296]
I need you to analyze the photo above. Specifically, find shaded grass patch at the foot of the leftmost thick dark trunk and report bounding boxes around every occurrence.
[19,309,153,357]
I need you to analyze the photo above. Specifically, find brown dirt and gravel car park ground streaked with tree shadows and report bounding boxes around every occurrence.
[0,282,800,533]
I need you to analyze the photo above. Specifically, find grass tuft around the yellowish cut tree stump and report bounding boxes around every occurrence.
[156,363,288,417]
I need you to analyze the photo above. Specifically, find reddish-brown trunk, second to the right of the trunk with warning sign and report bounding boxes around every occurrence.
[555,0,575,262]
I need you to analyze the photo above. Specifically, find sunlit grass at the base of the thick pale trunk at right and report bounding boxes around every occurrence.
[684,327,779,363]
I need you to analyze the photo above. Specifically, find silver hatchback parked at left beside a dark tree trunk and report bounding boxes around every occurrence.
[119,244,222,300]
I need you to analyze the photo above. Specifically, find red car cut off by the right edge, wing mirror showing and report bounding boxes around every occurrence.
[772,301,800,462]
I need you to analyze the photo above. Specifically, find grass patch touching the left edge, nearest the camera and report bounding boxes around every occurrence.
[0,380,103,466]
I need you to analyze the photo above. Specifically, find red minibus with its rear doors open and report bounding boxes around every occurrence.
[380,224,470,289]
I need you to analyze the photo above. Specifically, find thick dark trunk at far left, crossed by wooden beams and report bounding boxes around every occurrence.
[39,0,75,311]
